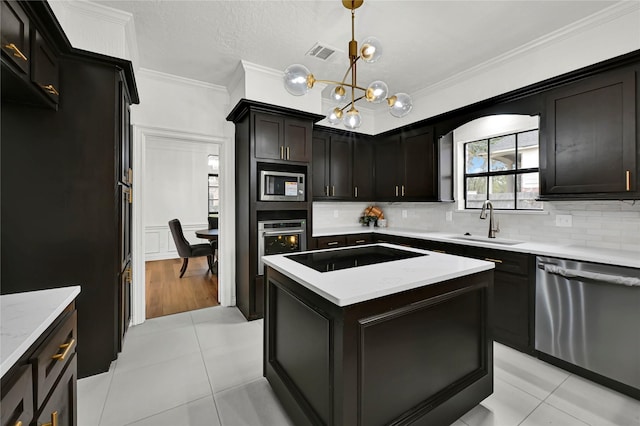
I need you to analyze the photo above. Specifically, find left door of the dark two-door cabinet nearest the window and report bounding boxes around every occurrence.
[375,136,401,201]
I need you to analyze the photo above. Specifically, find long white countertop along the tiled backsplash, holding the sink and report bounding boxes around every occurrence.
[313,226,640,268]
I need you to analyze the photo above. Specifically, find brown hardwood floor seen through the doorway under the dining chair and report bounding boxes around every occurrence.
[145,257,219,319]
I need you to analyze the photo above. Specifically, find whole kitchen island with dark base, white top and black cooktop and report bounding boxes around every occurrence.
[263,244,494,425]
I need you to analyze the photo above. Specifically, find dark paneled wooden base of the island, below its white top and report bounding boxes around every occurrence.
[264,267,493,426]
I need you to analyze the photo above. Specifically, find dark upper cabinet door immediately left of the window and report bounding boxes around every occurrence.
[400,128,436,199]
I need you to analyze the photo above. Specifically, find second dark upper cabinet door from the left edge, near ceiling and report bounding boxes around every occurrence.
[31,30,60,104]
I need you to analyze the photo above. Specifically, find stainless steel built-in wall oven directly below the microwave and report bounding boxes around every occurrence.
[258,219,307,275]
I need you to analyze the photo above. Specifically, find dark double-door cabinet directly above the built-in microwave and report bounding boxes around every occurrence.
[253,113,312,163]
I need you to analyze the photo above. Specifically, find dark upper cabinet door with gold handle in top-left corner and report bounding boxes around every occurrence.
[0,0,31,74]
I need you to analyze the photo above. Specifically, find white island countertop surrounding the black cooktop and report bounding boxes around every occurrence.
[262,244,494,306]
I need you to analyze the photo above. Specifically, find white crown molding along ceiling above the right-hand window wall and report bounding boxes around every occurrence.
[413,0,640,99]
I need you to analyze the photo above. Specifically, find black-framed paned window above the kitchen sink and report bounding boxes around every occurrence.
[464,130,542,210]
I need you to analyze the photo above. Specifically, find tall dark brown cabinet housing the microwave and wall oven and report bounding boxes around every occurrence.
[227,100,322,320]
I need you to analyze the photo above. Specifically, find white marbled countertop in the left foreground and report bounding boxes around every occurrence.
[0,286,80,377]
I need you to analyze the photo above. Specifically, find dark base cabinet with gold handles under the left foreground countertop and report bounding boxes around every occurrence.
[0,303,78,426]
